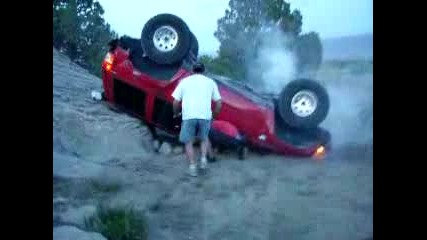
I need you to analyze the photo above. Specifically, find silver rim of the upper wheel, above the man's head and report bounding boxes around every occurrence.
[153,26,178,52]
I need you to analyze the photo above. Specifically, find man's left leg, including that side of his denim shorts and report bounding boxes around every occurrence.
[179,119,197,176]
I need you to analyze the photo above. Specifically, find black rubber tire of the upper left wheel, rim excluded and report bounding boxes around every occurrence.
[141,14,191,65]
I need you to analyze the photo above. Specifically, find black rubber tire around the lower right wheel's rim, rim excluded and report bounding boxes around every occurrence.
[278,79,330,128]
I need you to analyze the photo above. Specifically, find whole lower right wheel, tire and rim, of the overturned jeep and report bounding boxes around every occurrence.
[278,79,329,128]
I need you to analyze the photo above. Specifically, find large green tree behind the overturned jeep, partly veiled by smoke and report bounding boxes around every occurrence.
[210,0,321,79]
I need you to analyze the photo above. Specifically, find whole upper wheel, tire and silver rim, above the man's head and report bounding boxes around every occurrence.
[141,14,191,64]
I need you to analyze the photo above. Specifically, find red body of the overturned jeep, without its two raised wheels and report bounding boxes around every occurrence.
[102,40,330,157]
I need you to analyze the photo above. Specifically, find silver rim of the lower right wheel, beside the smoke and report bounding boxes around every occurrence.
[291,90,317,117]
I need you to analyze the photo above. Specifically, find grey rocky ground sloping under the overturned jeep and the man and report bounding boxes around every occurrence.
[53,47,373,240]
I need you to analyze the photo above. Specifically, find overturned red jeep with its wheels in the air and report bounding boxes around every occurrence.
[102,14,331,158]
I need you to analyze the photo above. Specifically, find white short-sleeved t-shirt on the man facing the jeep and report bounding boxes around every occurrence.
[172,74,221,120]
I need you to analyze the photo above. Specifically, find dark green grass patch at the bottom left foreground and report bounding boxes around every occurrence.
[84,205,148,240]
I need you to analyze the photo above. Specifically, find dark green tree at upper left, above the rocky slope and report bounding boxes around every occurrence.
[53,0,117,75]
